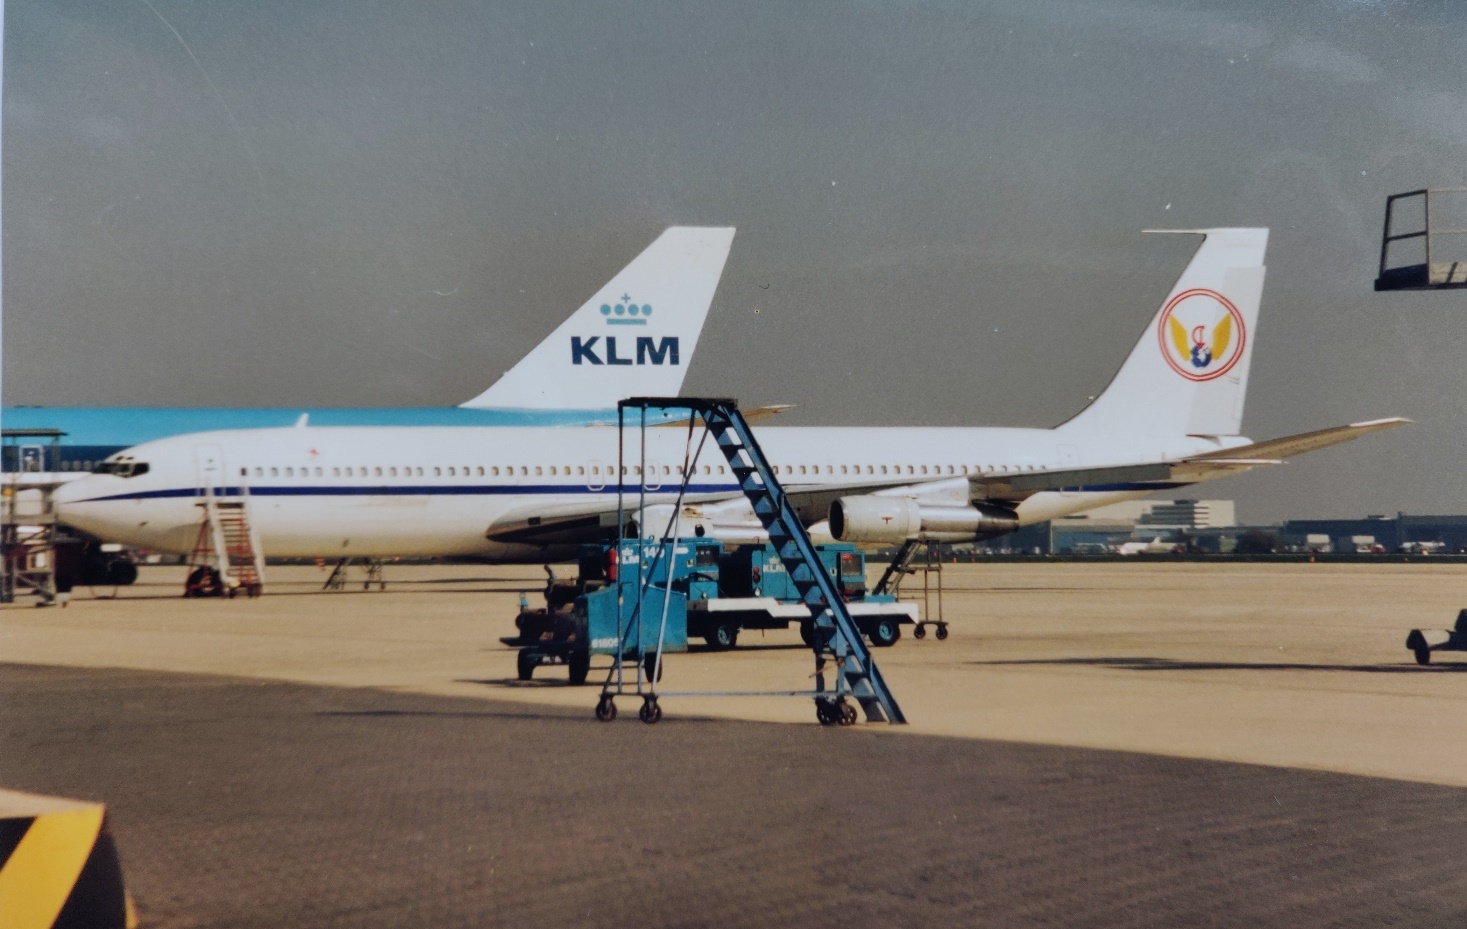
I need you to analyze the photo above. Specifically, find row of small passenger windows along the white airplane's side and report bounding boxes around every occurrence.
[239,464,1034,477]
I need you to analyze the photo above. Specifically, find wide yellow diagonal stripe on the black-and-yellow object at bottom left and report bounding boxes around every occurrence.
[0,806,103,929]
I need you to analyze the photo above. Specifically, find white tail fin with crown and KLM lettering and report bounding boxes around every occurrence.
[462,226,734,409]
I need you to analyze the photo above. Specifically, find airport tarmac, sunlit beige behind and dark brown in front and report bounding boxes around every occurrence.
[0,562,1467,926]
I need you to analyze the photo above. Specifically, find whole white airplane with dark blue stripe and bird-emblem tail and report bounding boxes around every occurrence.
[59,229,1408,562]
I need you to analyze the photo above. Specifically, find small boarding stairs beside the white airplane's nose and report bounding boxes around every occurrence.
[183,480,266,597]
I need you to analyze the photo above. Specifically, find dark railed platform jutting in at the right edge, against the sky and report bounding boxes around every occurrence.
[1375,186,1467,291]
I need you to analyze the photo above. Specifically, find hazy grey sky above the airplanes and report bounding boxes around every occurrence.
[3,0,1467,520]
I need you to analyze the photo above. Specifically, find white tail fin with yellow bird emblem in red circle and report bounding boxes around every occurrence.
[1059,229,1269,436]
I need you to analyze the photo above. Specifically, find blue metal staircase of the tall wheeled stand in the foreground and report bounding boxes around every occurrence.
[603,398,907,725]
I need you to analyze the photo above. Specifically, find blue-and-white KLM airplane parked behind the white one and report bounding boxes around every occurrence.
[0,226,735,483]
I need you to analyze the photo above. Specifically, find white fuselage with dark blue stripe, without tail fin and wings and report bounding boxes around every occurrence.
[62,427,1247,561]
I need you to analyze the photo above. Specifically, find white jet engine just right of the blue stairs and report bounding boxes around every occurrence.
[830,495,1018,543]
